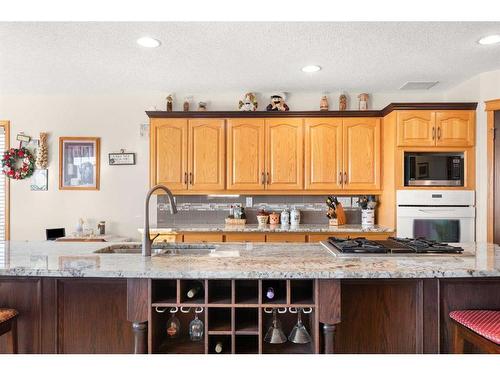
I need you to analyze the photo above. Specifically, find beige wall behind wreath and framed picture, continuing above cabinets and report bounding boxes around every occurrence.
[0,89,476,240]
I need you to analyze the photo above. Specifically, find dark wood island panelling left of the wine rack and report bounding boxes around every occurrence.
[0,277,134,354]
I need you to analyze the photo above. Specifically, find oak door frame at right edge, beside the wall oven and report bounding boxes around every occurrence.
[484,99,500,243]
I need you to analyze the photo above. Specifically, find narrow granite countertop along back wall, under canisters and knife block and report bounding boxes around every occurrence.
[139,224,394,234]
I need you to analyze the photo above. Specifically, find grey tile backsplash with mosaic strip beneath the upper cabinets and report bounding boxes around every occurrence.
[157,195,370,227]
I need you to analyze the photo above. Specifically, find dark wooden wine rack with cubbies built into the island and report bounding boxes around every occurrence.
[148,279,320,354]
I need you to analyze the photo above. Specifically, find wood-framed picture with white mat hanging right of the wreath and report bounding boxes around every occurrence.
[59,137,100,190]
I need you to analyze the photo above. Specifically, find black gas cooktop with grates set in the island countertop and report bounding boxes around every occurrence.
[322,237,464,256]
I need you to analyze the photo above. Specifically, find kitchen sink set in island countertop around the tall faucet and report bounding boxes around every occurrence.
[94,242,217,256]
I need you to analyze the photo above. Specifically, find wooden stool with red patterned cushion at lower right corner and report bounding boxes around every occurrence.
[450,310,500,354]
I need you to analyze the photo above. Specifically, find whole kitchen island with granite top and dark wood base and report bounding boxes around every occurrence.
[0,242,500,353]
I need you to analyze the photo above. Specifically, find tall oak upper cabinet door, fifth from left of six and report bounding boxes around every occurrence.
[304,118,342,190]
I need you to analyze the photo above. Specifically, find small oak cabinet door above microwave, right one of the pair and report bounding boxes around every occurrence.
[436,111,475,147]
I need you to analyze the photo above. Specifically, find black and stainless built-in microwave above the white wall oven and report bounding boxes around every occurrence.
[404,152,464,186]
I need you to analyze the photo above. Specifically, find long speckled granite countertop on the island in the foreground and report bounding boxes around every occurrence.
[0,241,500,278]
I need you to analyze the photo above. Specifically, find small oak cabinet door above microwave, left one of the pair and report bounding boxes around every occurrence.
[397,111,436,146]
